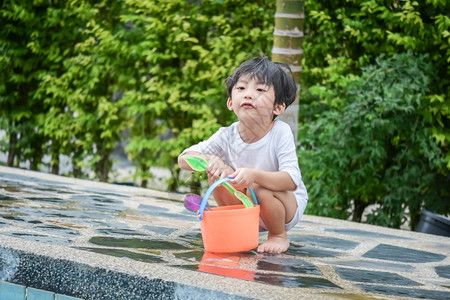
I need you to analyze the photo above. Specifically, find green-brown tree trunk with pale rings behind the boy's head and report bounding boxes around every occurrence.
[272,0,305,143]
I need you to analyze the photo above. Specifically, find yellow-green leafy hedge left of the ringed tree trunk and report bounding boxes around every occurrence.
[0,0,275,185]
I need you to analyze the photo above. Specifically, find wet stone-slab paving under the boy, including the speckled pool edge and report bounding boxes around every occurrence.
[0,167,450,299]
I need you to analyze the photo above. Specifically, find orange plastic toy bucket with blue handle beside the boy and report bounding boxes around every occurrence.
[198,178,259,253]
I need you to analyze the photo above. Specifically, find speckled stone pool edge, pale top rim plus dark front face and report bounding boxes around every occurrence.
[0,236,338,299]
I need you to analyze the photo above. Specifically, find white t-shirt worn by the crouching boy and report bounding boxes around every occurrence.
[181,120,308,206]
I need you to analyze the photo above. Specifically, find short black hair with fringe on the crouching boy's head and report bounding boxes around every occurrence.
[226,56,297,108]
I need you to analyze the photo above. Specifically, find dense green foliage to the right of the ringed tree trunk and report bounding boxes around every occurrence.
[299,0,450,227]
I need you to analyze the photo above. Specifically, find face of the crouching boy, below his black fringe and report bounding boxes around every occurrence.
[227,74,285,122]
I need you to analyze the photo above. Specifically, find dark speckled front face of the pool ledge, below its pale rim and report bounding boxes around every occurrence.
[0,248,243,300]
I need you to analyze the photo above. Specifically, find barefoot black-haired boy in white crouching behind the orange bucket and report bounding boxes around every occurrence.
[178,57,308,253]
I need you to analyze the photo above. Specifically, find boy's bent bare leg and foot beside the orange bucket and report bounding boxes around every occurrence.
[254,187,297,253]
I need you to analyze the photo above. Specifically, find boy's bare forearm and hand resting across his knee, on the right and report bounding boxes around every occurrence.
[230,168,297,191]
